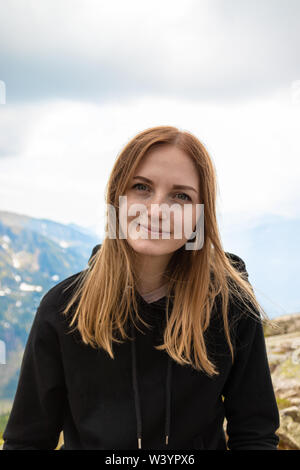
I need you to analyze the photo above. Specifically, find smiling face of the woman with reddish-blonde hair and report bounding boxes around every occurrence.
[120,145,200,255]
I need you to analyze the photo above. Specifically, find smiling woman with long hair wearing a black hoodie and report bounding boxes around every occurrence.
[3,126,279,450]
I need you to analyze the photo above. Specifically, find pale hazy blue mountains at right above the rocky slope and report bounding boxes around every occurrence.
[220,214,300,318]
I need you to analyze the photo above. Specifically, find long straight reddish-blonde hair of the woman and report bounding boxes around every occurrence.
[63,126,267,376]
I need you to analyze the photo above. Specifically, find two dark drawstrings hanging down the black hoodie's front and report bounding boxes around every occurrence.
[131,323,172,449]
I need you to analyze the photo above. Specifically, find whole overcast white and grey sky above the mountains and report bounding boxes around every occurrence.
[0,0,300,237]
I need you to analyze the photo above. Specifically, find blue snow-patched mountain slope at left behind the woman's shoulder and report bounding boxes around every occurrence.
[0,211,101,402]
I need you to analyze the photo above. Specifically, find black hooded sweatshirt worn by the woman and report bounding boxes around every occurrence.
[3,245,279,450]
